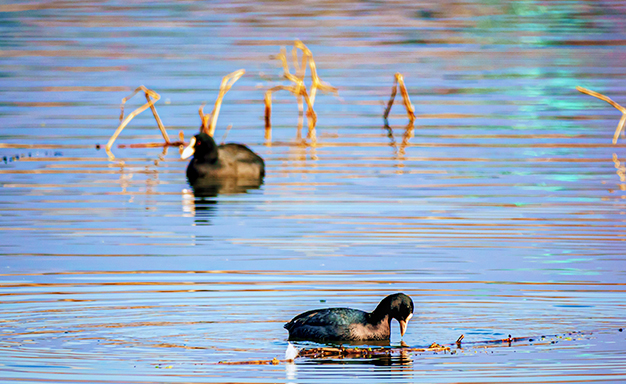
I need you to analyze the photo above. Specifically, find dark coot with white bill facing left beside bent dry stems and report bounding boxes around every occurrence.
[180,133,265,185]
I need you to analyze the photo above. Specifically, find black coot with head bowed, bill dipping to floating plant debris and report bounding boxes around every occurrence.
[285,293,413,341]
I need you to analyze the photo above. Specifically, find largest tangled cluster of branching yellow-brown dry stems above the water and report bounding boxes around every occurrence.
[264,40,337,142]
